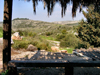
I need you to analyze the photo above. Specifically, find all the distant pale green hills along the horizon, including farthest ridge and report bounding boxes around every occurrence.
[0,18,78,33]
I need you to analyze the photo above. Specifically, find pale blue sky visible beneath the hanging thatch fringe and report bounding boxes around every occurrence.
[0,0,86,22]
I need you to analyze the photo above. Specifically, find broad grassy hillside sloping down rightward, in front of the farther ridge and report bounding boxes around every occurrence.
[12,20,78,33]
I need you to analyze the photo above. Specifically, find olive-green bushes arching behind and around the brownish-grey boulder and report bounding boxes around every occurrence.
[12,37,50,51]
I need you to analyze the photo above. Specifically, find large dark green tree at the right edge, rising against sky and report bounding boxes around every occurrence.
[77,5,100,47]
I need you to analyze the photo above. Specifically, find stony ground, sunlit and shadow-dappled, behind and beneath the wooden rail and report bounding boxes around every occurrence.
[0,46,100,75]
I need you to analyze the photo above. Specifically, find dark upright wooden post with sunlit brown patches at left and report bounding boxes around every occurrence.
[3,0,12,71]
